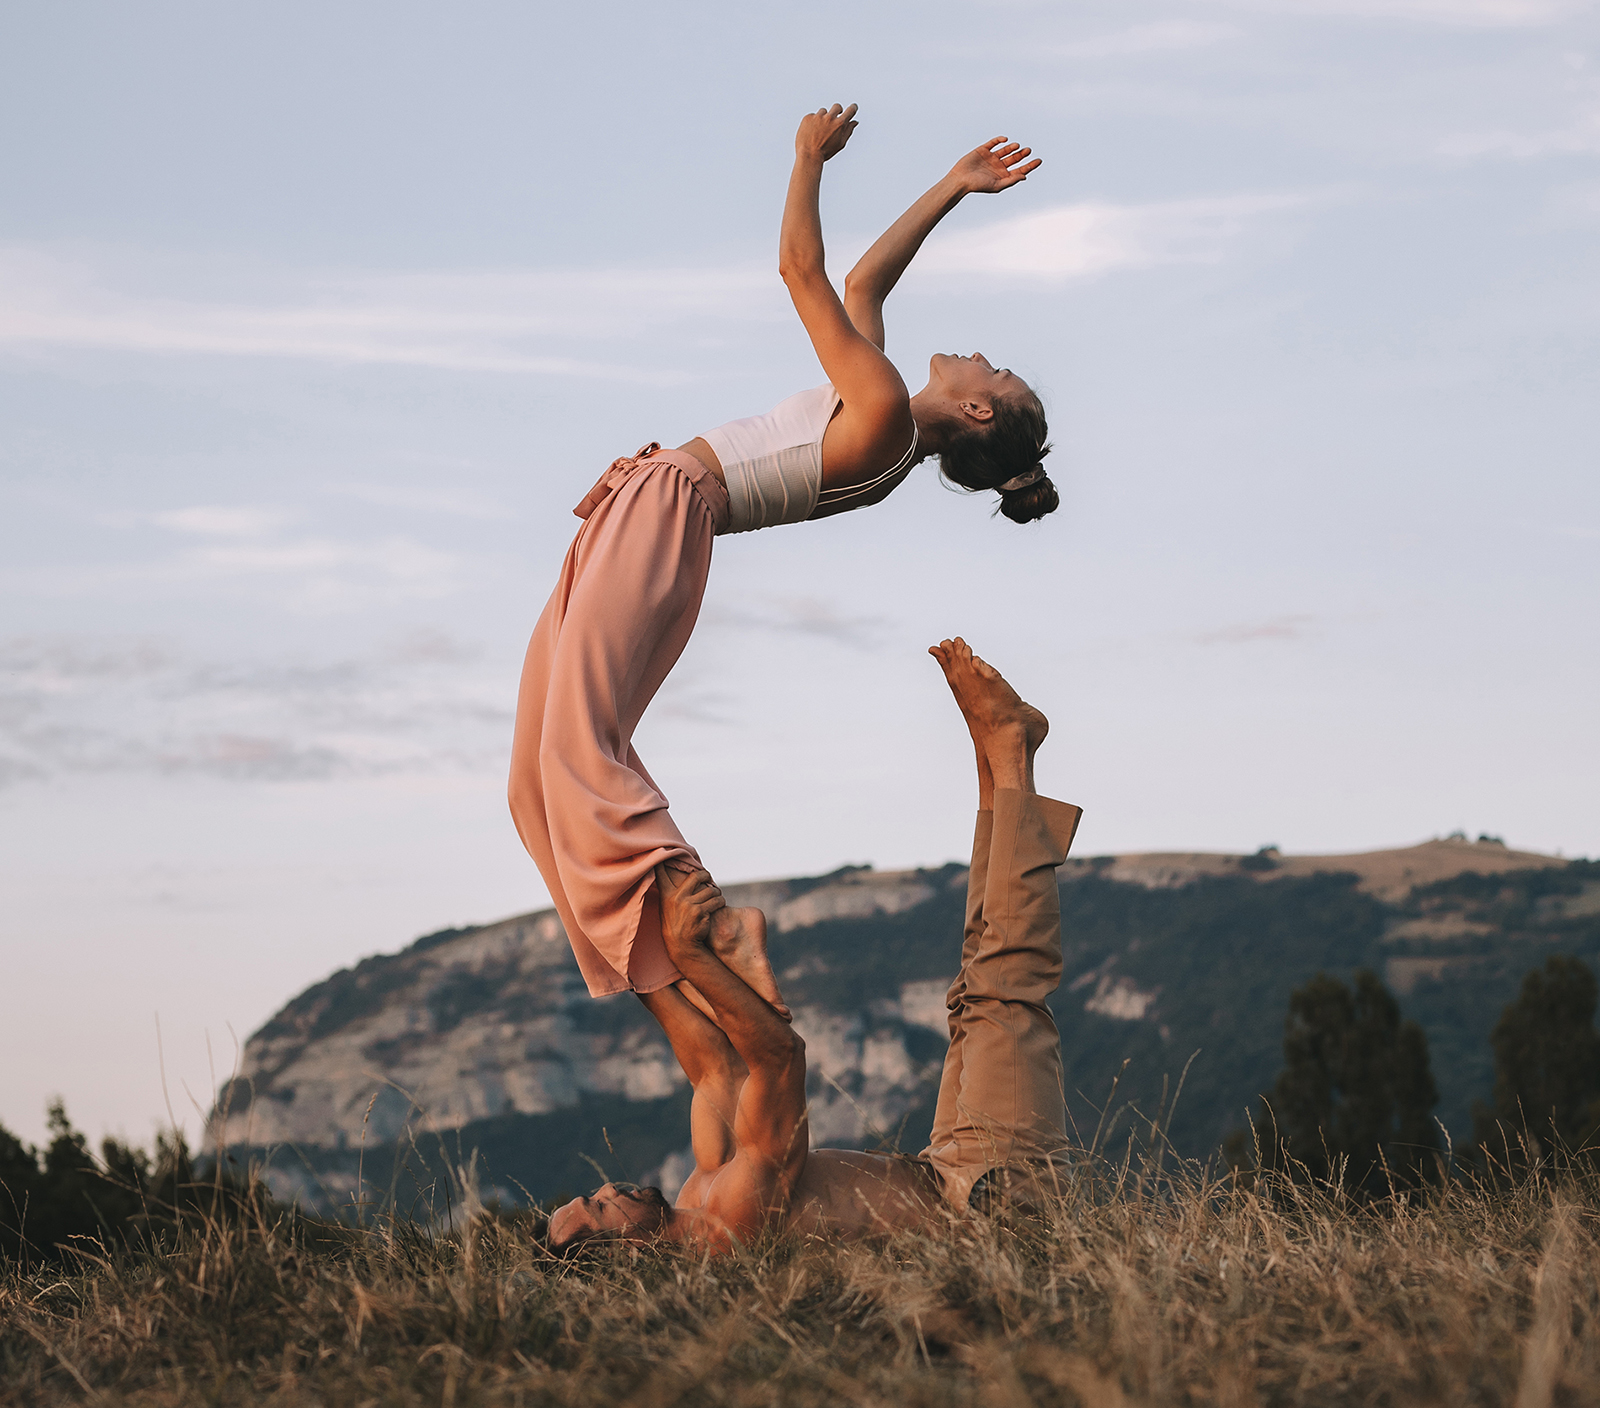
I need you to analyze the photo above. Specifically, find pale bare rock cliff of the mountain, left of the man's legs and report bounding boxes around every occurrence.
[218,867,966,1192]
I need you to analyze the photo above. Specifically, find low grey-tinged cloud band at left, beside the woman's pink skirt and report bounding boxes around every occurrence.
[0,632,510,786]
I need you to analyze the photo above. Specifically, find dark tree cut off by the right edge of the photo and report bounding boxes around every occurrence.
[1474,954,1600,1157]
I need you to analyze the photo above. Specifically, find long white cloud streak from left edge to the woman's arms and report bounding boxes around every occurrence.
[0,246,784,384]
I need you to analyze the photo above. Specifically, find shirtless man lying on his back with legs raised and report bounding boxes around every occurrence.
[550,637,1080,1250]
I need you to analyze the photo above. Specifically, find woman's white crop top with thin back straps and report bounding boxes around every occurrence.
[704,384,917,533]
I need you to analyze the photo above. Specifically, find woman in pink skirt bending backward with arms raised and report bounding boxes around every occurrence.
[509,104,1058,1014]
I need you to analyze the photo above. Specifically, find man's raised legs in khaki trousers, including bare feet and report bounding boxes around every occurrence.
[925,640,1080,1205]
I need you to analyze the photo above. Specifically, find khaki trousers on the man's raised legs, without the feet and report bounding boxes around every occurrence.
[923,790,1082,1206]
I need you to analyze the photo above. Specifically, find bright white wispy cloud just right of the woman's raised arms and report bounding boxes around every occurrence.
[915,192,1336,280]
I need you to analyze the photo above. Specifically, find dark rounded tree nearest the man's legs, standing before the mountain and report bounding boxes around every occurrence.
[1232,970,1440,1197]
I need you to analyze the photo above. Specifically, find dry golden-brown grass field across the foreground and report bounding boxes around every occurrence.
[0,1171,1600,1408]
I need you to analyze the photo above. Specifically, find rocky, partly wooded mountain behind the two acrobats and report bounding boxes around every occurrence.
[216,840,1600,1203]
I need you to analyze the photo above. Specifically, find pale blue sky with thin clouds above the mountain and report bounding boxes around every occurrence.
[0,0,1600,1141]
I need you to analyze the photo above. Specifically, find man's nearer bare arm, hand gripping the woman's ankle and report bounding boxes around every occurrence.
[656,870,810,1240]
